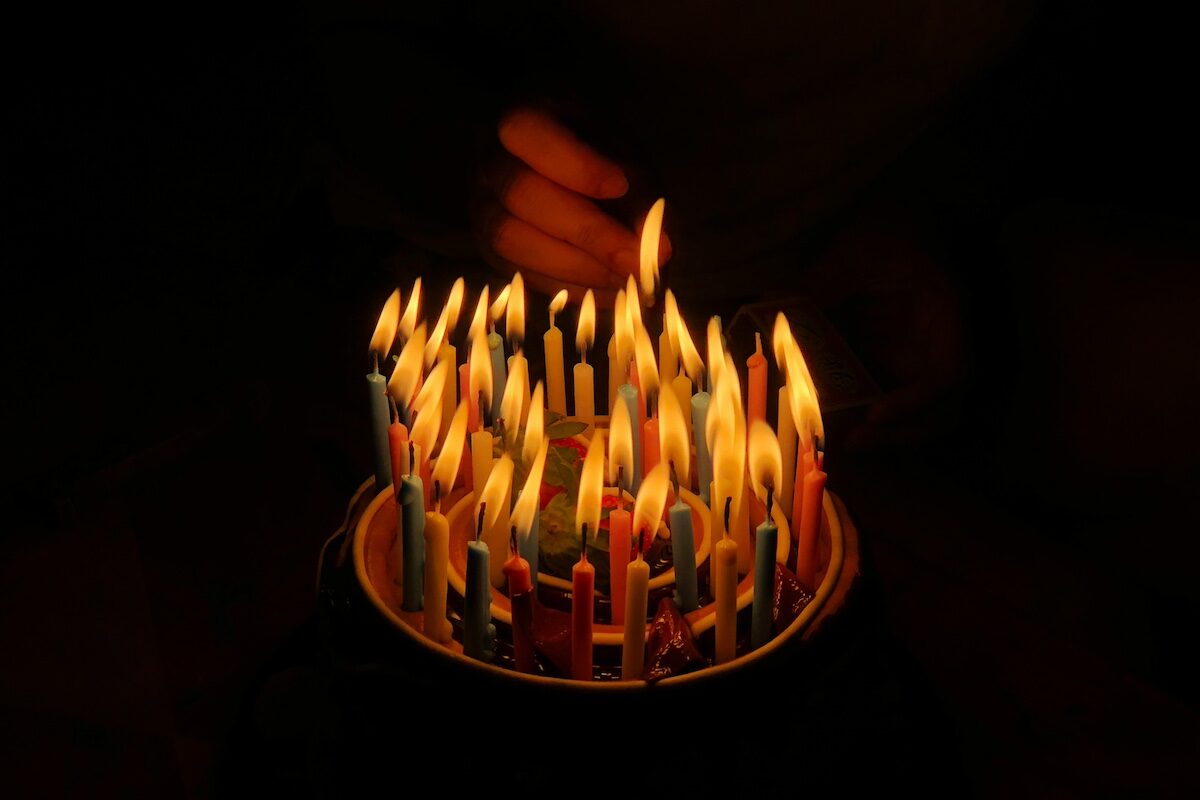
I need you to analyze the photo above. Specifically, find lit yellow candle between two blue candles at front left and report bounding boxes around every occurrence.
[425,403,467,644]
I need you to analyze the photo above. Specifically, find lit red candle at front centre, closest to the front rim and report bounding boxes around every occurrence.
[571,431,604,680]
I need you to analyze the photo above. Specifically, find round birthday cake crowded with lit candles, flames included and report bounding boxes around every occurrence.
[338,201,857,688]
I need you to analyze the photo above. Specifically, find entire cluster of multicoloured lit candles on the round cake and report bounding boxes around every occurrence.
[367,200,826,680]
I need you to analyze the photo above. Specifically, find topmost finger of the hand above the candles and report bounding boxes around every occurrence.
[498,108,629,200]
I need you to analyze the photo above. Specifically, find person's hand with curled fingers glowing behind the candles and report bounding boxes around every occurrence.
[473,108,671,302]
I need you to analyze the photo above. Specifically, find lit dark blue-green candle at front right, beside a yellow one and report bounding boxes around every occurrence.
[750,420,784,648]
